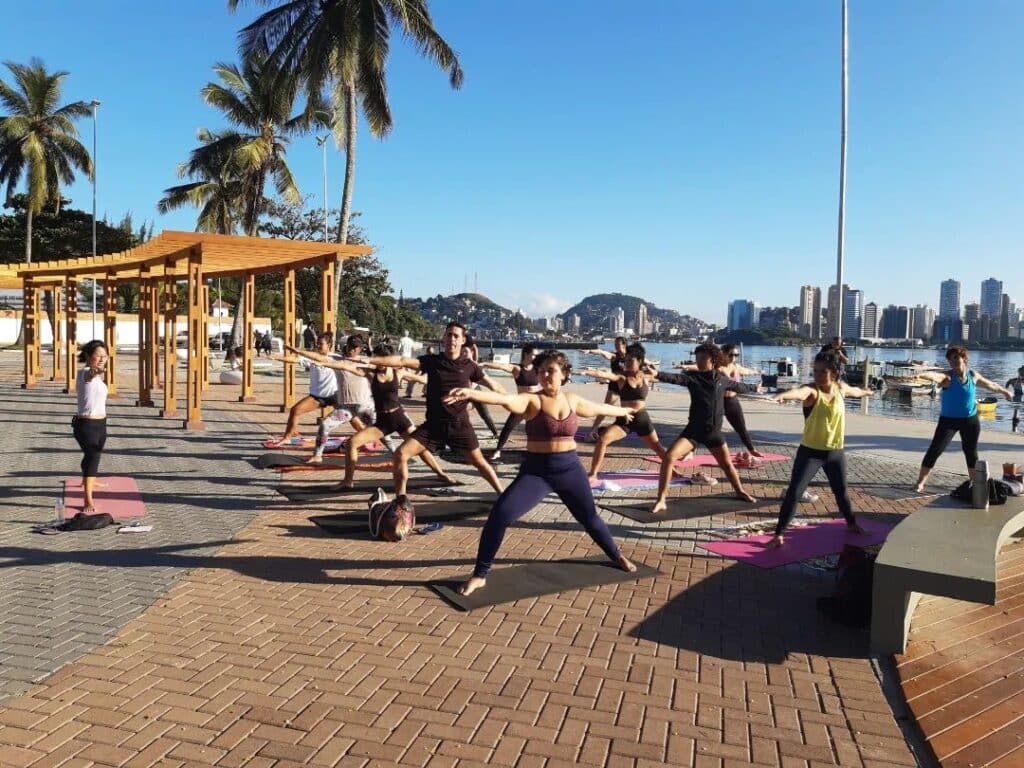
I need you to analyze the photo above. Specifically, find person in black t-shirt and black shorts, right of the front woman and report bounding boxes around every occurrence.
[651,343,761,514]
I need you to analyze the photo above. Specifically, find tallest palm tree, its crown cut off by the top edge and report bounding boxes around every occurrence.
[227,0,463,325]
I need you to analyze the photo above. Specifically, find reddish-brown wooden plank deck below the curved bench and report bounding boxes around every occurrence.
[896,540,1024,768]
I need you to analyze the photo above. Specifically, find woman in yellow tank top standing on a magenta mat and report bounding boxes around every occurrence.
[767,352,871,547]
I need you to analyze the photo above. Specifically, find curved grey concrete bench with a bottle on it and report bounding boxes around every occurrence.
[871,496,1024,654]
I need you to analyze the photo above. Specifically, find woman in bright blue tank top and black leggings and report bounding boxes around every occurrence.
[915,347,1014,494]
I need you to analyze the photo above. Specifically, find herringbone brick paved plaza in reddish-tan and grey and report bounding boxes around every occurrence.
[0,352,1015,768]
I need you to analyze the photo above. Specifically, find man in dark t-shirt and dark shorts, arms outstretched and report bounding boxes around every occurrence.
[368,323,503,496]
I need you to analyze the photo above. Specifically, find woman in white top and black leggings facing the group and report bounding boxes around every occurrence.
[72,340,108,514]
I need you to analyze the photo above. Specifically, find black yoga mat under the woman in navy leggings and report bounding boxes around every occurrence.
[429,556,660,611]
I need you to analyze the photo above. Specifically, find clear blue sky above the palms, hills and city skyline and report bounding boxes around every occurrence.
[0,0,1024,323]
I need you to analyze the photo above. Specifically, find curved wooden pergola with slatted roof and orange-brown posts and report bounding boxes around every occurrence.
[0,231,373,429]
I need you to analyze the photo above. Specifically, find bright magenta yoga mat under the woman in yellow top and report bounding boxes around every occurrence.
[697,519,894,568]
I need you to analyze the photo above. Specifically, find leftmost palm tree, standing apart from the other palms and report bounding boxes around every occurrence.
[0,58,92,263]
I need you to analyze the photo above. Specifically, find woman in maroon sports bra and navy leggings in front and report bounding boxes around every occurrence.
[445,350,636,595]
